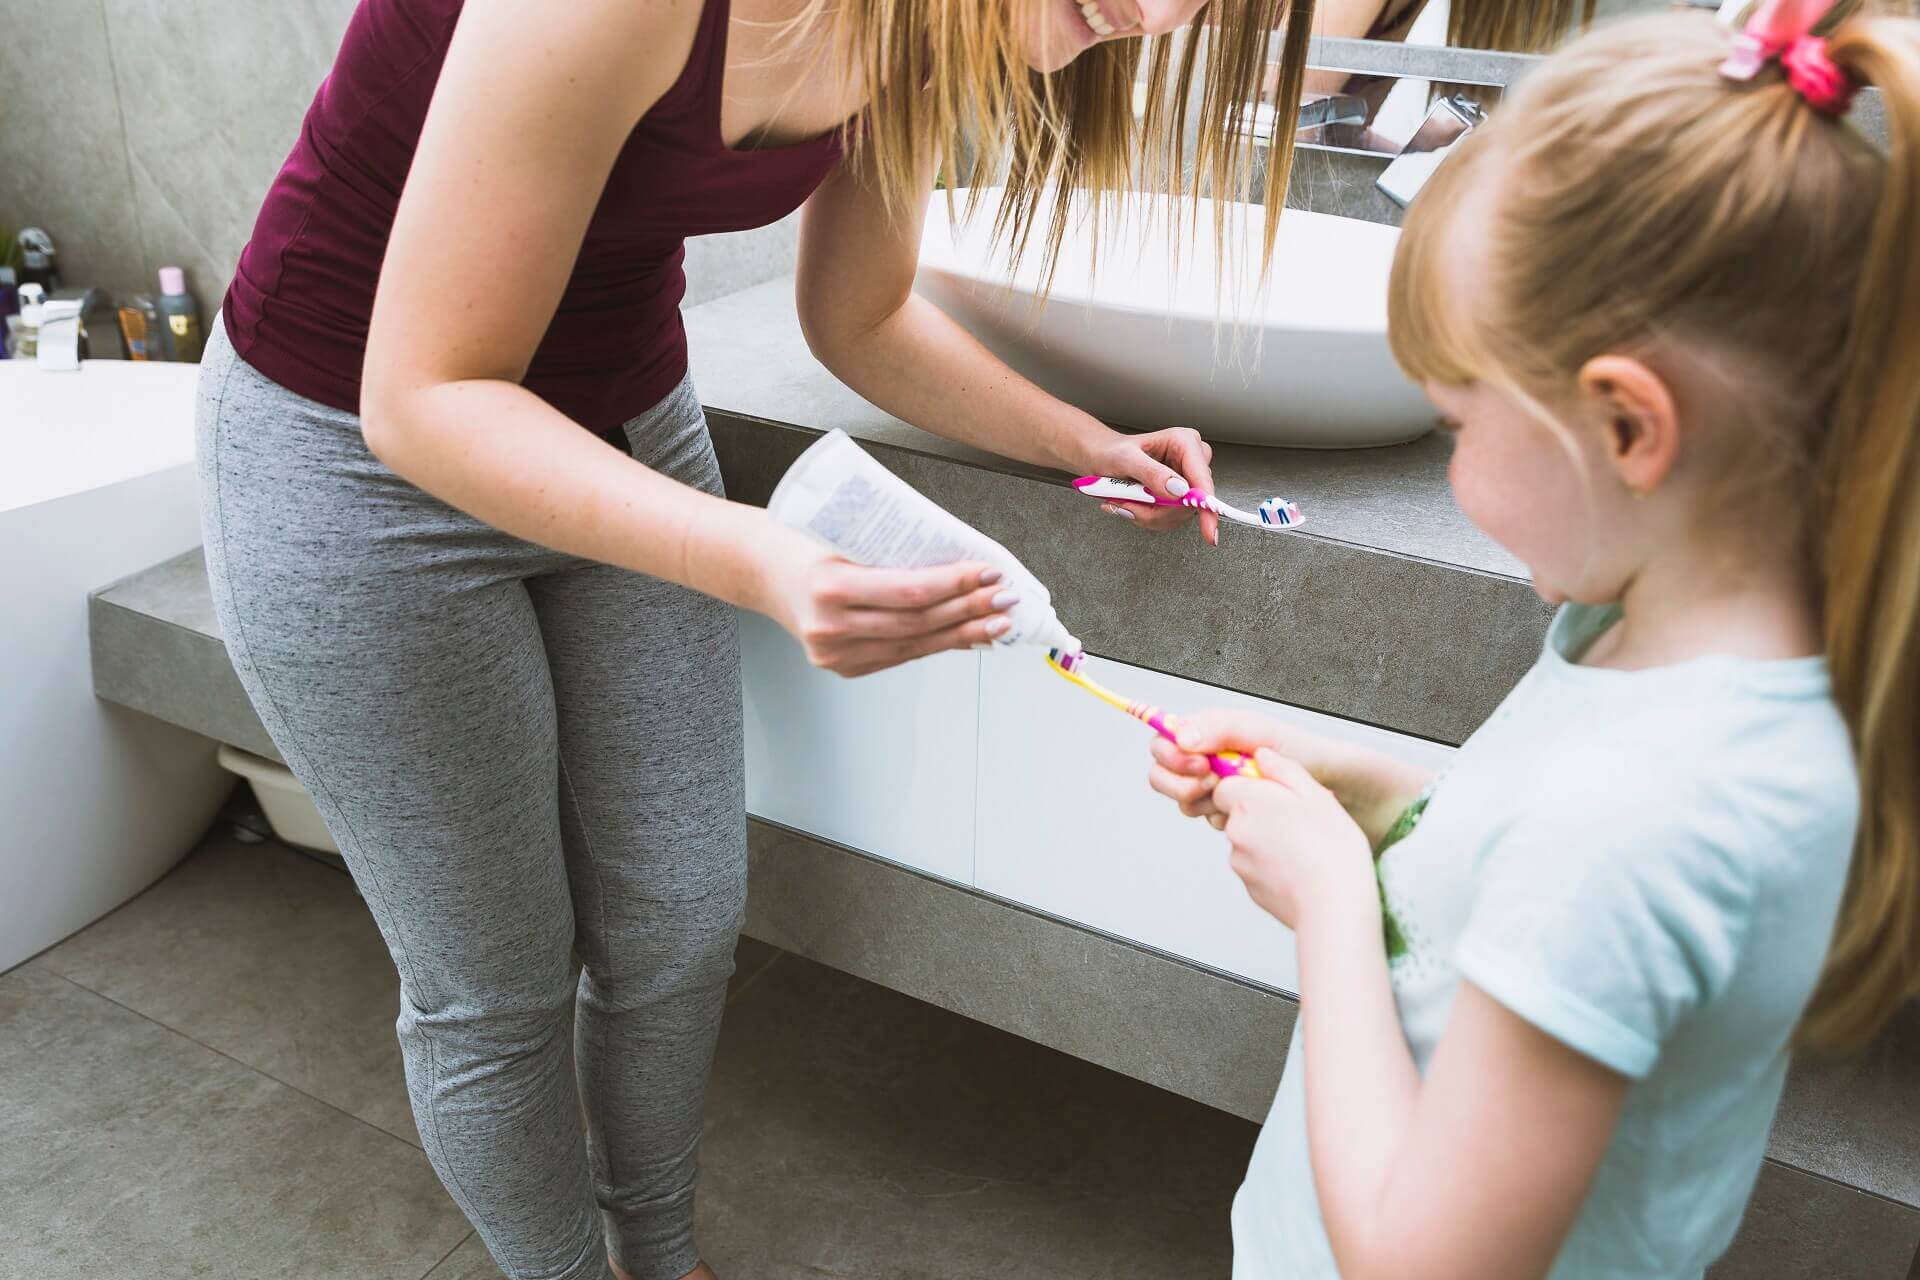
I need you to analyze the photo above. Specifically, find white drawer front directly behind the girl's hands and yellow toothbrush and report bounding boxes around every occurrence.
[973,651,1453,992]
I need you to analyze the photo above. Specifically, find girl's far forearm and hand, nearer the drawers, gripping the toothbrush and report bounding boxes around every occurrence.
[1148,710,1432,846]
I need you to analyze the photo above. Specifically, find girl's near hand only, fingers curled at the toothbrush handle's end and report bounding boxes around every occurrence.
[1213,748,1379,929]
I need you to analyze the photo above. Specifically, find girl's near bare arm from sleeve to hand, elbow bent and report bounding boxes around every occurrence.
[1213,750,1628,1280]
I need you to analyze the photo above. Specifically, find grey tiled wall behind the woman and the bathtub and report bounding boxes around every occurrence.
[0,0,795,311]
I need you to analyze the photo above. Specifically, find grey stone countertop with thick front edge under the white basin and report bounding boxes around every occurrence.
[685,278,1551,743]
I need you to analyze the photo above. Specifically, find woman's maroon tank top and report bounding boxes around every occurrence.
[223,0,841,436]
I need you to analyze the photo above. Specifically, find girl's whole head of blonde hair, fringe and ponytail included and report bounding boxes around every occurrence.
[1390,15,1920,1050]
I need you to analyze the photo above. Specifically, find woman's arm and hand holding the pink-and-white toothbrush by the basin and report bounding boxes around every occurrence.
[795,148,1219,541]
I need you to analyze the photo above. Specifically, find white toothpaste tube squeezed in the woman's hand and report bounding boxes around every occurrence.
[766,430,1083,654]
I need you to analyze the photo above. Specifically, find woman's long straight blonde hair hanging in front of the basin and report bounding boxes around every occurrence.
[793,0,1313,271]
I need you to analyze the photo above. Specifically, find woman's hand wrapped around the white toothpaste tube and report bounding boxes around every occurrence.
[762,535,1016,676]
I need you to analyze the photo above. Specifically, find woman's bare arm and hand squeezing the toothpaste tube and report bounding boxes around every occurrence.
[361,0,993,674]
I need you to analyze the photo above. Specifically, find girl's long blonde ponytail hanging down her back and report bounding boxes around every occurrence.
[1801,19,1920,1050]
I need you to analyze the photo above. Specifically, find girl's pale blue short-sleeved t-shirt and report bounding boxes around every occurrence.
[1233,606,1859,1280]
